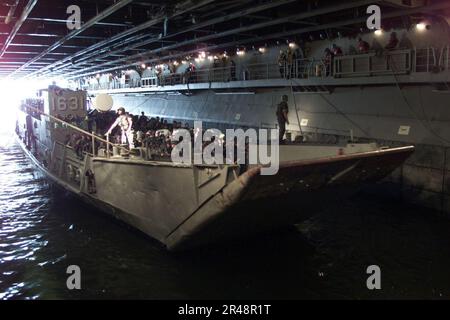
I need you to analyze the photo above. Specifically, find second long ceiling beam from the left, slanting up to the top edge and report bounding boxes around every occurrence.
[6,0,133,77]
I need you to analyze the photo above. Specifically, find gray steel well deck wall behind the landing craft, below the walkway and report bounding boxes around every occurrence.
[104,80,450,214]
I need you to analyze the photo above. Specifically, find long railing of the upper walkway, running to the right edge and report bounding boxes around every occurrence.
[84,46,450,90]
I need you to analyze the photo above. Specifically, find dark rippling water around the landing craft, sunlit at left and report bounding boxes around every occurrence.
[0,134,450,299]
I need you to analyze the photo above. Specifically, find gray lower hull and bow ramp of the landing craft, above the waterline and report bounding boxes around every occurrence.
[15,132,414,250]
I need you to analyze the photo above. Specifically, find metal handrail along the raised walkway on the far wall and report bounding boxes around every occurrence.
[88,47,450,90]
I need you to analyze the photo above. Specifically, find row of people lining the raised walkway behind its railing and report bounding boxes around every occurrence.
[81,32,411,89]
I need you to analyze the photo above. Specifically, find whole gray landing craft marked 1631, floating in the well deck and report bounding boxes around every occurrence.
[16,86,414,250]
